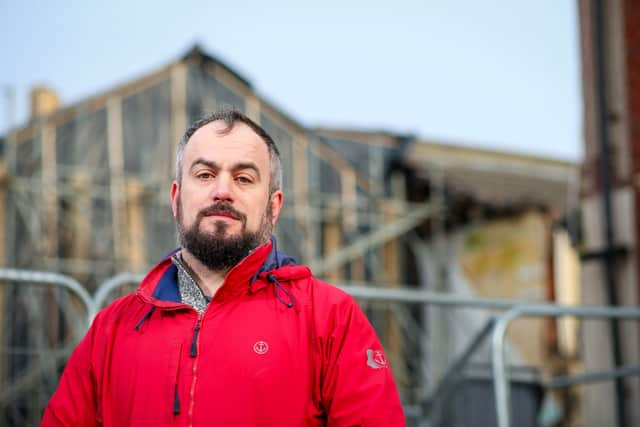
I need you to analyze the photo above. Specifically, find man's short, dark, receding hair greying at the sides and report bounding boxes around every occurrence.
[176,108,282,193]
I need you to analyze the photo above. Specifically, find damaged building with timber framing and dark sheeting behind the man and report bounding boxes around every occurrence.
[0,46,581,425]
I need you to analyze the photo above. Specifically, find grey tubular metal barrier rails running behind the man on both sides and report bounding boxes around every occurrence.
[0,269,640,427]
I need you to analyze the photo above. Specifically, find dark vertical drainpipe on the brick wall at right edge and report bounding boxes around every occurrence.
[592,0,626,427]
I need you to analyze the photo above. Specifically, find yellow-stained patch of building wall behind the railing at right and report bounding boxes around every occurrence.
[457,212,551,366]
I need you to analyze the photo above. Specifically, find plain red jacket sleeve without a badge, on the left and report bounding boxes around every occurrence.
[40,312,99,427]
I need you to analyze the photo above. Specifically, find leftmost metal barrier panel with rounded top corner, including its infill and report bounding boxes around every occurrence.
[0,269,95,426]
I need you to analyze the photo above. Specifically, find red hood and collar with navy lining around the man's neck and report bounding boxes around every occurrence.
[136,236,311,308]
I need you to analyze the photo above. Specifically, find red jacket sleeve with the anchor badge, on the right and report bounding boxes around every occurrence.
[321,296,405,427]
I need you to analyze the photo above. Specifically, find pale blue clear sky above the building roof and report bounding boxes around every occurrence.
[0,0,583,161]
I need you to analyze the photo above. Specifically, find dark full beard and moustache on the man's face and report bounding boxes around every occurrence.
[176,198,273,271]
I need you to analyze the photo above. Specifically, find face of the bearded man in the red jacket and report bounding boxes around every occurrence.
[171,122,282,267]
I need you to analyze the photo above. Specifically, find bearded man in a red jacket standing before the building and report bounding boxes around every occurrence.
[42,111,404,427]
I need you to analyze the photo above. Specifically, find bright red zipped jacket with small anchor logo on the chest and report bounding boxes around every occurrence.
[41,243,404,427]
